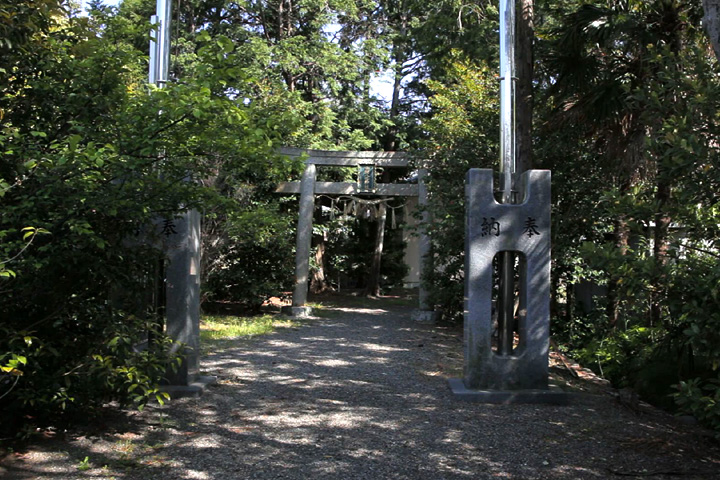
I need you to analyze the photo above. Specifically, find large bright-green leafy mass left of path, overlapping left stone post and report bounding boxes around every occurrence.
[0,2,292,436]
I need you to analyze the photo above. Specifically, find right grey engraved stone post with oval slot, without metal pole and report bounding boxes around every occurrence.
[450,169,565,403]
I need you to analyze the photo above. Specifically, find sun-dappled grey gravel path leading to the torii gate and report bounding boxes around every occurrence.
[0,300,720,480]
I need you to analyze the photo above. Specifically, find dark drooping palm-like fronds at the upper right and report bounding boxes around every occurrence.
[548,0,693,186]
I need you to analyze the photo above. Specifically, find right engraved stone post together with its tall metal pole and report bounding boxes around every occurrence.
[450,0,568,403]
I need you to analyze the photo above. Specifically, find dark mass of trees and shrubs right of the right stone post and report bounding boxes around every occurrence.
[540,1,720,425]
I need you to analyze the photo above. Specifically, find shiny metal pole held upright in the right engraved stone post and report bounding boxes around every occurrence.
[498,0,516,355]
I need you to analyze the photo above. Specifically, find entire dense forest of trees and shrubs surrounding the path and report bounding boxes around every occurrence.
[0,0,720,431]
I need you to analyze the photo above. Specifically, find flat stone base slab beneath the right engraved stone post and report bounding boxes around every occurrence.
[448,378,572,405]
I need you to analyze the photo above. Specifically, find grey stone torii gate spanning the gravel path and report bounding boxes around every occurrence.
[276,144,435,323]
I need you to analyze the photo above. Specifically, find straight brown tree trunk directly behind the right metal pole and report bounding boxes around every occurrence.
[515,0,535,174]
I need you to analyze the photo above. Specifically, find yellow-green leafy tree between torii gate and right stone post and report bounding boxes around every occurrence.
[418,55,499,320]
